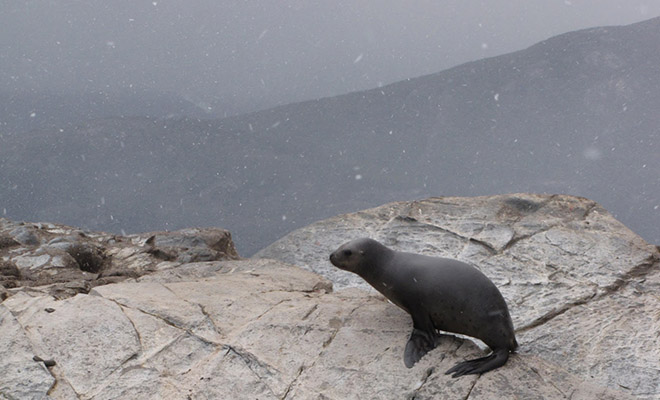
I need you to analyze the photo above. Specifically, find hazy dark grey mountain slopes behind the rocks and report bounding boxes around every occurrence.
[0,19,660,255]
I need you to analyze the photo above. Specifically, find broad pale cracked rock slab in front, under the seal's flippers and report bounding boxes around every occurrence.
[3,260,628,399]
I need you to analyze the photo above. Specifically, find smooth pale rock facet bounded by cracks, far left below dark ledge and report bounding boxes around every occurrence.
[3,294,139,396]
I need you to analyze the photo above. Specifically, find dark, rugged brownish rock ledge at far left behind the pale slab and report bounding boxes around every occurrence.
[0,218,238,300]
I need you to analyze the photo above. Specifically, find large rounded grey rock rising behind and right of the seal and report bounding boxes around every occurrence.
[255,194,660,399]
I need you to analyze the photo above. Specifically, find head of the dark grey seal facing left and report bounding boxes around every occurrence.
[330,238,389,275]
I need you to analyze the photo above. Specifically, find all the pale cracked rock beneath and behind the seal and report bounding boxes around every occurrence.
[0,195,660,400]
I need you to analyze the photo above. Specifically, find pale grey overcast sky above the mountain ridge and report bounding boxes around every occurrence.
[0,0,660,112]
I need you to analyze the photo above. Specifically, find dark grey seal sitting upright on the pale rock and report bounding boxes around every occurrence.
[330,238,518,378]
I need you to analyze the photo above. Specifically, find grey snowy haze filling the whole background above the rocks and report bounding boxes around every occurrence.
[0,0,660,255]
